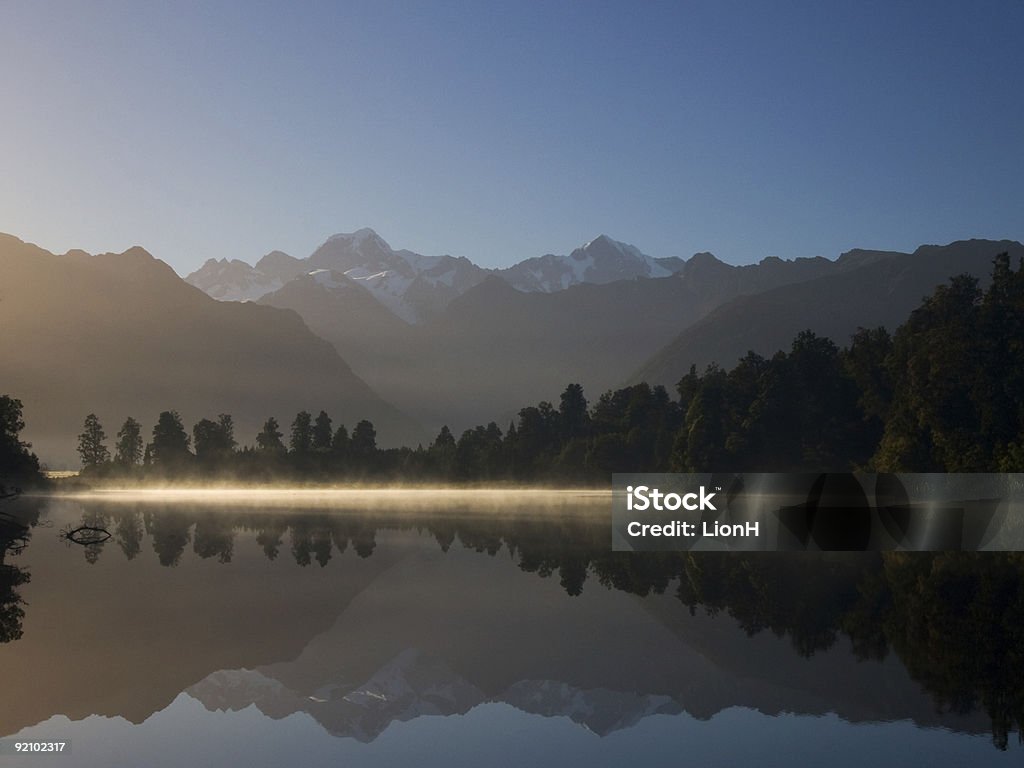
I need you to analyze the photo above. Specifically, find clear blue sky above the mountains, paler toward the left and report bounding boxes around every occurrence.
[0,0,1024,273]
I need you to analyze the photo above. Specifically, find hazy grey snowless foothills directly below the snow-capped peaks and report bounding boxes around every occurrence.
[261,246,845,431]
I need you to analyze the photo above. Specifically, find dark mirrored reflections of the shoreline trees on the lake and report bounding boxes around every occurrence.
[12,505,1024,749]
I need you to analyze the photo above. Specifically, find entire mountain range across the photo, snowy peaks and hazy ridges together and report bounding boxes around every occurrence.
[0,229,1024,465]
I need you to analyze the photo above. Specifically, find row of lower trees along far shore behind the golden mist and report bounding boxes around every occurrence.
[72,376,680,482]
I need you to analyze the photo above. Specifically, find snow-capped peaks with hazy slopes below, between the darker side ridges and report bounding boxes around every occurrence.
[203,229,836,432]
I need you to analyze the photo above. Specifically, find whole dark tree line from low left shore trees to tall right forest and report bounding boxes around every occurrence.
[70,254,1024,483]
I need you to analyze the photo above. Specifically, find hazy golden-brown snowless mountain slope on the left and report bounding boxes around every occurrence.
[0,236,422,465]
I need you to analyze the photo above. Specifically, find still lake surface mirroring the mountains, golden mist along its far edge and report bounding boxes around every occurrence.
[0,492,1024,766]
